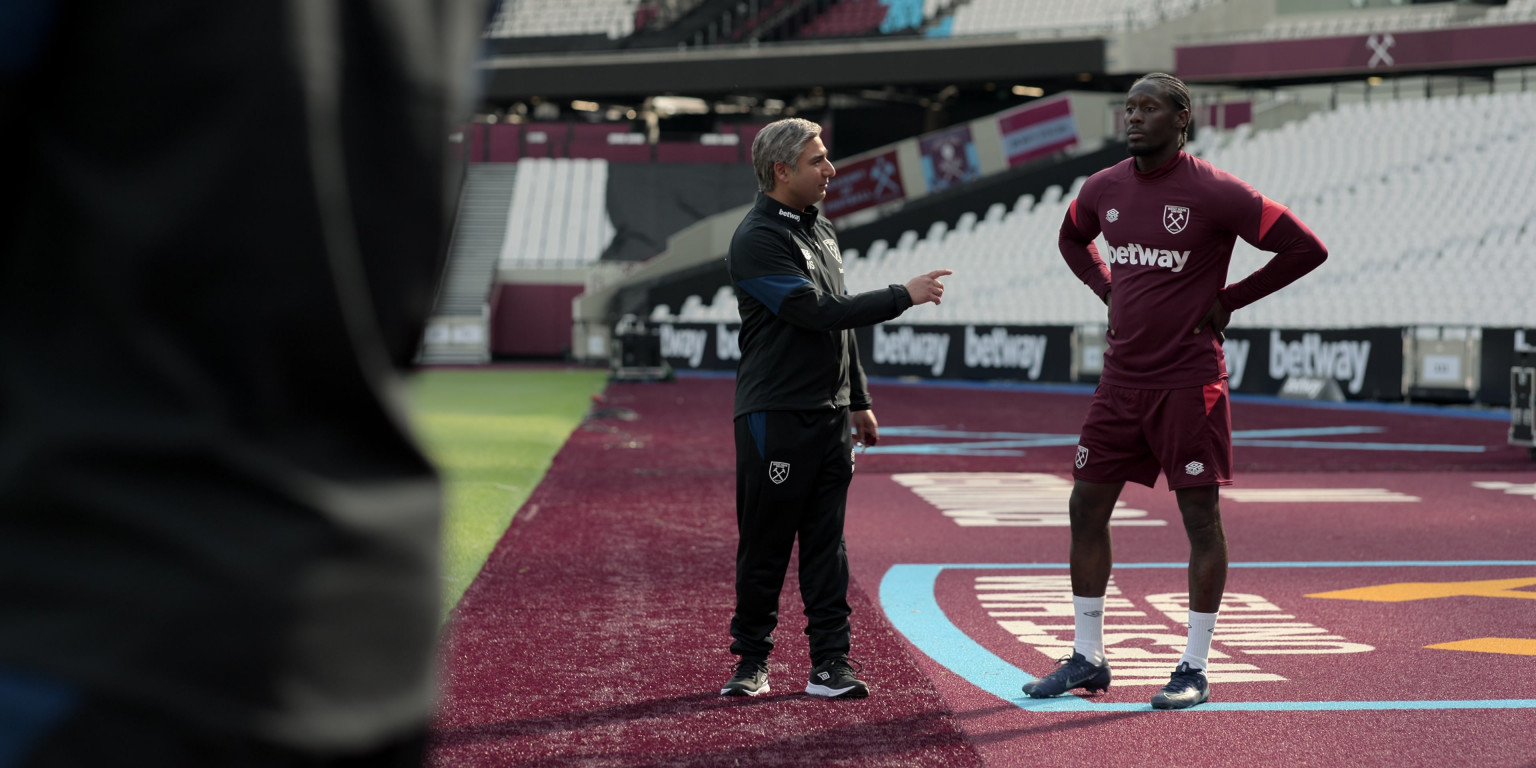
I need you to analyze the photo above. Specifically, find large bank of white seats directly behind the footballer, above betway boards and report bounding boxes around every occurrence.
[672,92,1536,327]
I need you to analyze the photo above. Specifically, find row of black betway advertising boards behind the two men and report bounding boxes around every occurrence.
[657,323,1536,406]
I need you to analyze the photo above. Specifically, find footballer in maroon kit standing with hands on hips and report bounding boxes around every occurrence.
[1025,72,1327,710]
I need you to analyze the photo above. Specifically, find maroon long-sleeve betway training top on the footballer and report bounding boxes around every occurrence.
[1058,152,1329,389]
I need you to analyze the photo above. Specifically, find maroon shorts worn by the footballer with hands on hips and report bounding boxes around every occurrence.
[1072,378,1232,490]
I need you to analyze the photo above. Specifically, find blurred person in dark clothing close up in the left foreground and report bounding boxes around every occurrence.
[0,0,485,768]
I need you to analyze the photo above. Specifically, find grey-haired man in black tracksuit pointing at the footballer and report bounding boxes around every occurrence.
[720,118,949,697]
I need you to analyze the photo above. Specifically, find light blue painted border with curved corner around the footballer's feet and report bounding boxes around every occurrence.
[880,561,1536,713]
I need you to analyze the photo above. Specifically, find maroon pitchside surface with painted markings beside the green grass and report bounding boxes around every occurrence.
[430,378,1536,766]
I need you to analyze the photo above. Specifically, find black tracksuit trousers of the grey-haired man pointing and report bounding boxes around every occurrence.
[731,409,854,664]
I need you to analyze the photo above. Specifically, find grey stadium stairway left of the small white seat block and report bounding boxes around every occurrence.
[416,163,518,364]
